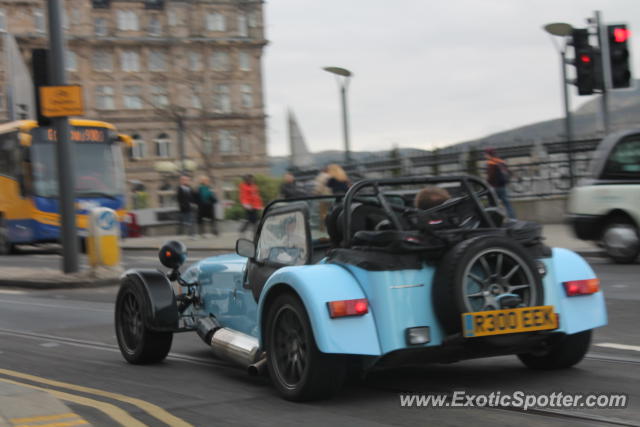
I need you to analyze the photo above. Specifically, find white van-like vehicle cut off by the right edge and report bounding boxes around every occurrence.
[567,130,640,263]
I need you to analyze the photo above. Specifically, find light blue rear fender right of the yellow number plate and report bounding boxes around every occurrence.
[544,248,607,334]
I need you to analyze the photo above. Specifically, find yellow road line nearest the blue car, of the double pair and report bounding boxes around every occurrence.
[0,368,192,427]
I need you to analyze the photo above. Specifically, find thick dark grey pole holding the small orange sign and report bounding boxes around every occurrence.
[47,0,78,273]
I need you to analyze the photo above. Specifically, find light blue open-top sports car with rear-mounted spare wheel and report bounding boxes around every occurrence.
[115,176,607,401]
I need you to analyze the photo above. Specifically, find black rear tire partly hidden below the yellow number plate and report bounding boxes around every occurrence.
[518,329,591,370]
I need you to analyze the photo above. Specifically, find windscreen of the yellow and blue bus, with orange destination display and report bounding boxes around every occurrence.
[31,127,124,197]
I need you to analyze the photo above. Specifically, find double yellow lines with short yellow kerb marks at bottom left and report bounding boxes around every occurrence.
[0,369,192,427]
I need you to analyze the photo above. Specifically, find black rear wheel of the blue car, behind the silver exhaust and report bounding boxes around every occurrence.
[266,293,347,402]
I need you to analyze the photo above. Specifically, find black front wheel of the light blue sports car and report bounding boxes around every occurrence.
[115,278,173,365]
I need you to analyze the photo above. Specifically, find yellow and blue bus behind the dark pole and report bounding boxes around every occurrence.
[0,119,130,254]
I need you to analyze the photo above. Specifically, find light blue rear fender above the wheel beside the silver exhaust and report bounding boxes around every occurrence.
[258,264,381,356]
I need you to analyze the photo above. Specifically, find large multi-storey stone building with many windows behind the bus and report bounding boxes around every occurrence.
[0,0,267,207]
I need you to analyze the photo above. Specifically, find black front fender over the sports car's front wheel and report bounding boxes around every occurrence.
[123,269,180,331]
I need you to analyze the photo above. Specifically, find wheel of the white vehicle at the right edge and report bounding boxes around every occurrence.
[602,214,640,264]
